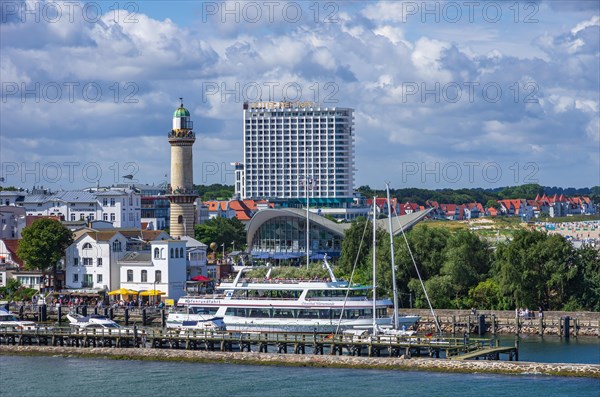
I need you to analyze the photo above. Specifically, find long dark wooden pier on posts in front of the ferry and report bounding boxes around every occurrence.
[0,327,518,361]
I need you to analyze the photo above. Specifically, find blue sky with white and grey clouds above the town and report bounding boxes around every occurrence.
[0,0,600,190]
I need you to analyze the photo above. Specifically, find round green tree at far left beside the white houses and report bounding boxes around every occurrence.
[17,218,73,290]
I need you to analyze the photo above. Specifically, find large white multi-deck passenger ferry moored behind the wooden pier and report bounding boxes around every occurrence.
[167,263,419,333]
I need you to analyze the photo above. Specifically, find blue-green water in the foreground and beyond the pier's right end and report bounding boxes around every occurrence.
[0,336,600,397]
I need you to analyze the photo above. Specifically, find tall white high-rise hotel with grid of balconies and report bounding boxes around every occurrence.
[235,102,354,207]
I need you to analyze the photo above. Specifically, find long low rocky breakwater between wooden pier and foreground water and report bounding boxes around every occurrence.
[0,346,600,378]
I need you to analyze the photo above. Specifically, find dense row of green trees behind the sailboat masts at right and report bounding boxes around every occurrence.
[336,219,600,311]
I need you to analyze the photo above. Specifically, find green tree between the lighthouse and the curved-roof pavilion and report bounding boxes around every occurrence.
[194,217,246,252]
